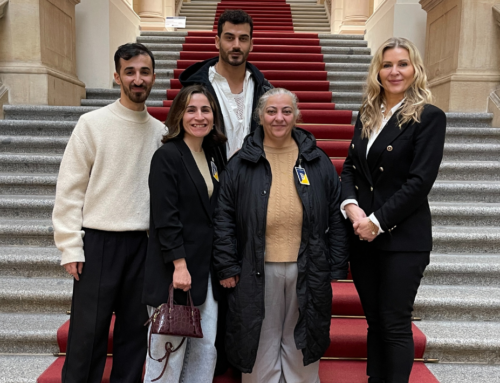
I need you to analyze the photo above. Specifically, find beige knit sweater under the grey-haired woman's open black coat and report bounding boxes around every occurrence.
[264,142,303,262]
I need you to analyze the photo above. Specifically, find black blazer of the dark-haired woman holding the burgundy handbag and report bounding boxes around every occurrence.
[143,138,224,307]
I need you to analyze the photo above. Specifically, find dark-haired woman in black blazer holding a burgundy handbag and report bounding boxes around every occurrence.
[143,85,226,383]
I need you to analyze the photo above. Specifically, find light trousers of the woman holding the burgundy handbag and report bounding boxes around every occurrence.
[144,277,217,383]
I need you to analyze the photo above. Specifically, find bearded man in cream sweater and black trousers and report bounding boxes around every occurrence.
[52,44,165,383]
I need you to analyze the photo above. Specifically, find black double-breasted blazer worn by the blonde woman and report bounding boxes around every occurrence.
[341,105,446,251]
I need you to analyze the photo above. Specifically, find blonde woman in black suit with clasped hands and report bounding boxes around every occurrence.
[341,38,446,383]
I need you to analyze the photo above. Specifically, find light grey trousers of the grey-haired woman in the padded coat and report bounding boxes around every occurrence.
[242,262,319,383]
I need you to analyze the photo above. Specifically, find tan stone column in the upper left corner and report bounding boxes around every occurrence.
[0,0,85,105]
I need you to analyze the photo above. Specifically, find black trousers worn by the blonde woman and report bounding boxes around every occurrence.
[351,250,430,383]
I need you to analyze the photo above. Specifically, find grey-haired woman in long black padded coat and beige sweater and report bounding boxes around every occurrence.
[214,88,347,383]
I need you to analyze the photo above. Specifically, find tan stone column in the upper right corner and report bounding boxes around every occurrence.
[420,0,500,112]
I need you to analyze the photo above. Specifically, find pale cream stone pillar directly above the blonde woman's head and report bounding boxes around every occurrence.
[365,0,427,57]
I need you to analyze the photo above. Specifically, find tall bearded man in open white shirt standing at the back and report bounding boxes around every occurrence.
[179,10,273,158]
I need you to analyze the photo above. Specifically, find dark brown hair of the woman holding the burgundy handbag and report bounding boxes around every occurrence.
[161,85,227,146]
